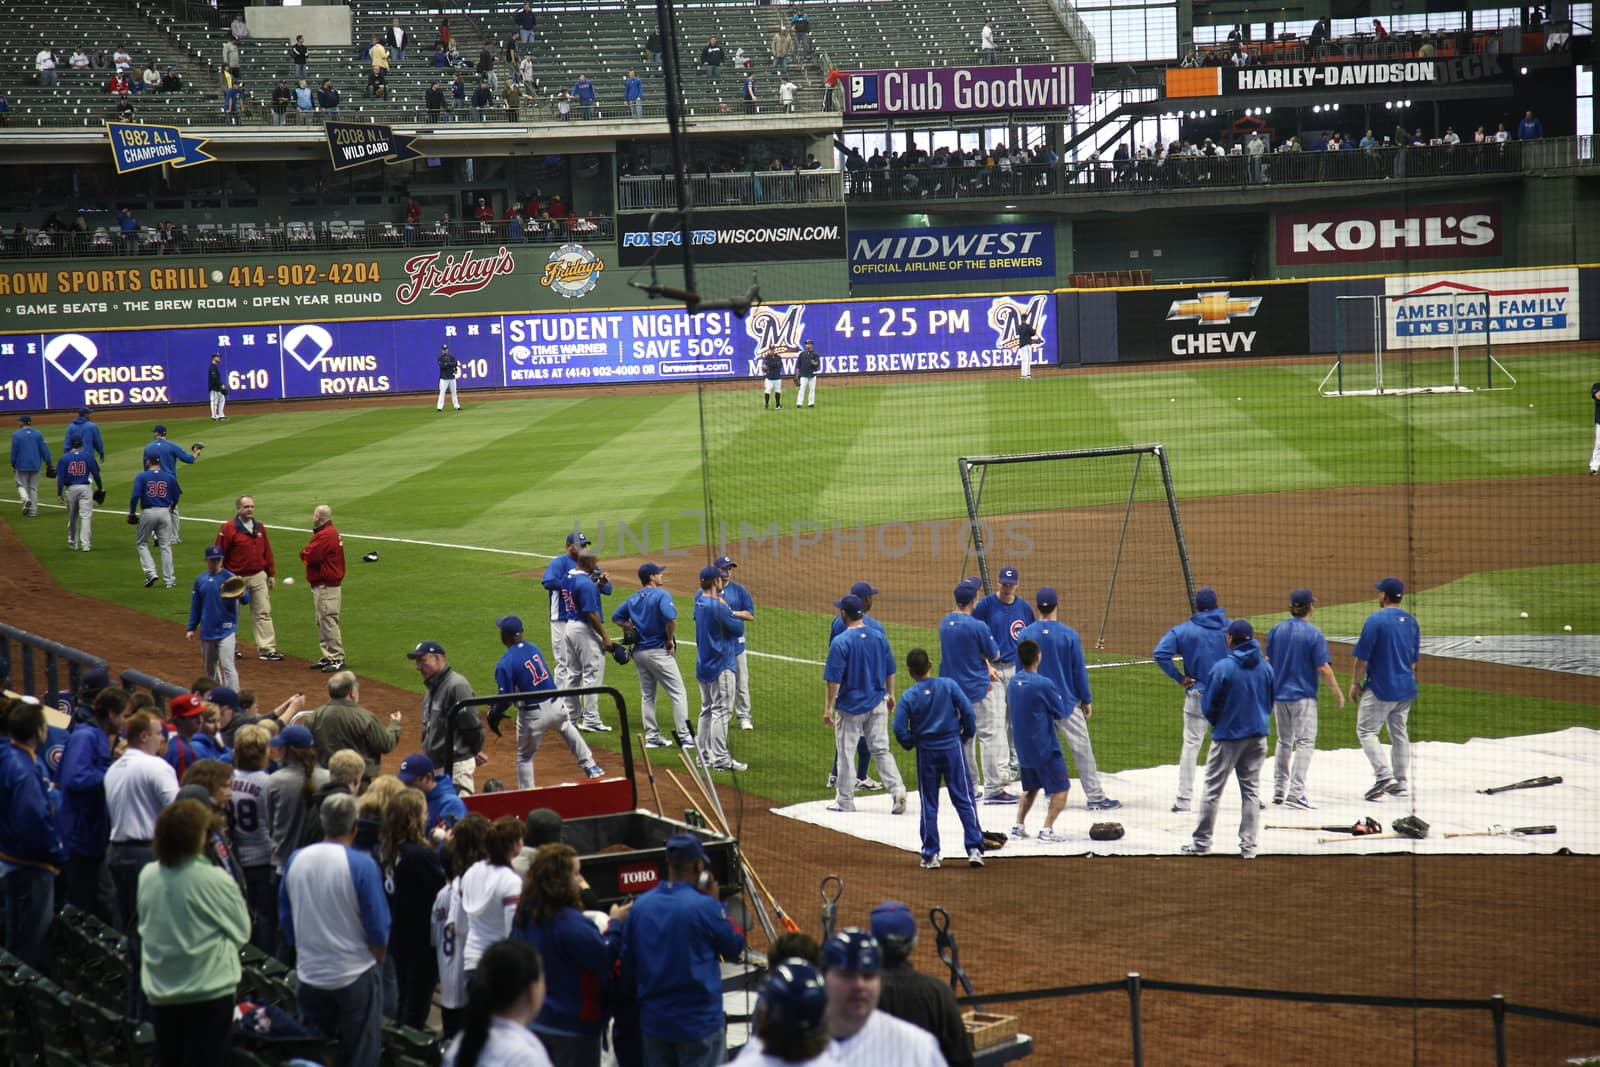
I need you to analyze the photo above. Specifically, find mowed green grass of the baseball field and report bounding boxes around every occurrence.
[8,352,1600,800]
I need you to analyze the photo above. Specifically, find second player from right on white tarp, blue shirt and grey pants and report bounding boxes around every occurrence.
[1267,589,1344,809]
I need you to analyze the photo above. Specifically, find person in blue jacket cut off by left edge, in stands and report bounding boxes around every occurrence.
[0,701,65,971]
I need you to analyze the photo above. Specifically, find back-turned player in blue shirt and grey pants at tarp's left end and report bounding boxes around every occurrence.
[822,593,906,814]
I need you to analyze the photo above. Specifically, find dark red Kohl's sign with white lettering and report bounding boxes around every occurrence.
[1275,203,1504,267]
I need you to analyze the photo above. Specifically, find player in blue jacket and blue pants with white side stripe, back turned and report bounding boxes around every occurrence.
[894,648,984,870]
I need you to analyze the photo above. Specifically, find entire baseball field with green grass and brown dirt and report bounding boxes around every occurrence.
[0,346,1600,1064]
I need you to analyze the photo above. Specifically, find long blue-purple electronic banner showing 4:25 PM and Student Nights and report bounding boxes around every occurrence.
[0,293,1056,411]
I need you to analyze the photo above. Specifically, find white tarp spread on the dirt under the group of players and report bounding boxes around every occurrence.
[778,726,1600,862]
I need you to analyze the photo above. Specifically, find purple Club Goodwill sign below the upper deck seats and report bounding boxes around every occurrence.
[845,62,1093,115]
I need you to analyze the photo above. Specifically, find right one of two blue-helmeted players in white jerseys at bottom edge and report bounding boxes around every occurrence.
[822,926,944,1067]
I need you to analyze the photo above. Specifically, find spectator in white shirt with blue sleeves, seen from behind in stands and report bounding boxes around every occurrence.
[278,797,390,1067]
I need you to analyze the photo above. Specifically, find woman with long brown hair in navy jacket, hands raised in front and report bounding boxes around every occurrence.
[510,845,629,1064]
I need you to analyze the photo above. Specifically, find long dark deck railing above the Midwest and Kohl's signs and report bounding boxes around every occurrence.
[845,136,1595,202]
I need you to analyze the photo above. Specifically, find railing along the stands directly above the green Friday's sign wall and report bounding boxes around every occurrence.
[0,216,616,259]
